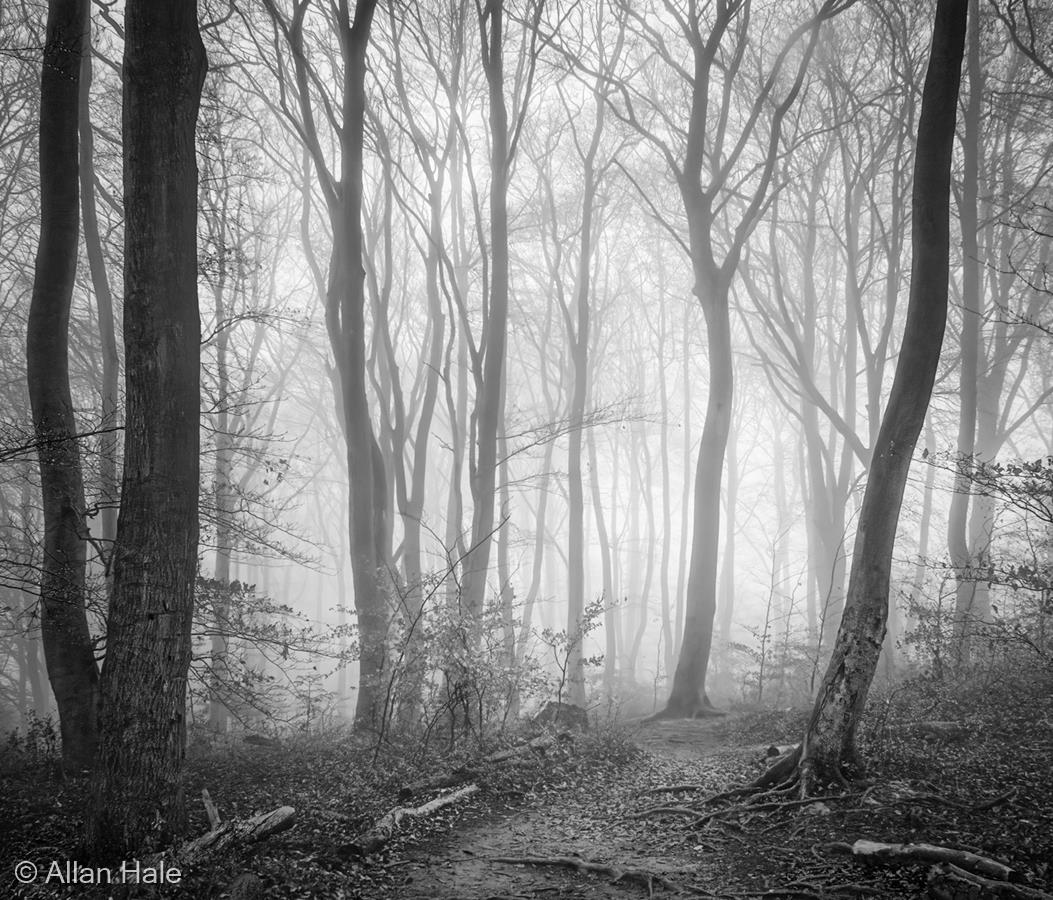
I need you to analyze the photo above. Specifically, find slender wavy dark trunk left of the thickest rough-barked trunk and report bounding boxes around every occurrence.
[25,0,99,769]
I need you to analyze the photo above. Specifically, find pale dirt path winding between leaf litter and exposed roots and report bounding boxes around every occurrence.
[397,719,756,900]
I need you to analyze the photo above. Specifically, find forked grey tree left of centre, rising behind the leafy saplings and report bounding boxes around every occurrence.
[254,0,391,726]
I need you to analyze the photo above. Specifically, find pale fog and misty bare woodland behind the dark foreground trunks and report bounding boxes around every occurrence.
[0,0,1053,858]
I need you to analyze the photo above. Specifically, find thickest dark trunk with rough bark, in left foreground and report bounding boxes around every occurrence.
[86,0,206,859]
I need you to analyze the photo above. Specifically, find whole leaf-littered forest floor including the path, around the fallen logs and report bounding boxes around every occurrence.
[0,681,1053,900]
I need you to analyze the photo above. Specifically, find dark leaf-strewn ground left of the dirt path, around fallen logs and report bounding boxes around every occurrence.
[0,726,637,900]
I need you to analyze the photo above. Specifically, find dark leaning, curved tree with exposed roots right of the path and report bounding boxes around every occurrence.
[758,0,969,795]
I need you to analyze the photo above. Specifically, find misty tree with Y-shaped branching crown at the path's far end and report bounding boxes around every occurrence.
[613,0,851,717]
